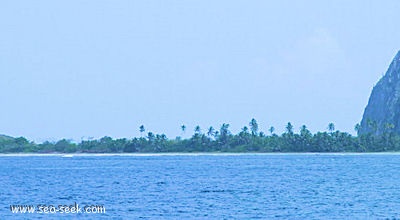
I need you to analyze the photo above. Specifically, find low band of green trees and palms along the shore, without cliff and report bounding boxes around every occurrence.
[0,119,400,153]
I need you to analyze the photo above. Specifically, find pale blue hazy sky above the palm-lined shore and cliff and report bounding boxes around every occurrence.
[0,0,400,142]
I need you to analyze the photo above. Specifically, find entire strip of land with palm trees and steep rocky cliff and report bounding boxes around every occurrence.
[0,52,400,153]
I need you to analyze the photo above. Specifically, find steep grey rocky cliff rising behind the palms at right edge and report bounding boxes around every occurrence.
[358,51,400,135]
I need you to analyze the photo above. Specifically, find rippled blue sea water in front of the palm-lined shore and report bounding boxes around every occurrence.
[0,154,400,219]
